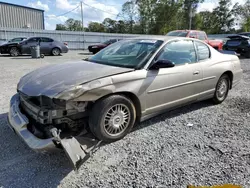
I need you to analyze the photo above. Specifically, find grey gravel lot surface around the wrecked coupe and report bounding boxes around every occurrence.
[0,51,250,188]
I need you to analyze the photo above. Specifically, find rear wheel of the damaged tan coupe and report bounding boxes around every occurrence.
[213,74,230,104]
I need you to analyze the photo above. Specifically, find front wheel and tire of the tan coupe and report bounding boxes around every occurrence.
[89,95,136,142]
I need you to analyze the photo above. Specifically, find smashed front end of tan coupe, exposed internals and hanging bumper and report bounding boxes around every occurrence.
[8,92,100,169]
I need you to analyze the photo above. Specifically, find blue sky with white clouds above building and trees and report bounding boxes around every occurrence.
[2,0,245,30]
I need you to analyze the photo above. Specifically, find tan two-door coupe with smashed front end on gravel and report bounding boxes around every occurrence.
[8,37,242,168]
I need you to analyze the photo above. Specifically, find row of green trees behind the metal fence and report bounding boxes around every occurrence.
[56,0,250,34]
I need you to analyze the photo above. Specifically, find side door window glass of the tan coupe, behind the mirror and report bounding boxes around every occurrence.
[156,40,196,66]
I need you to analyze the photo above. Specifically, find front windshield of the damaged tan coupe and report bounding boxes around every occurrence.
[88,39,163,68]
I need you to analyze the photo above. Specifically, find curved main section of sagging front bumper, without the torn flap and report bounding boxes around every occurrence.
[8,94,57,152]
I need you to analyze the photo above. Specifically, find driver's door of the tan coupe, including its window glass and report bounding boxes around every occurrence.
[146,39,202,114]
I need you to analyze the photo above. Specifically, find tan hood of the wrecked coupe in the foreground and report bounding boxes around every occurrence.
[17,61,133,97]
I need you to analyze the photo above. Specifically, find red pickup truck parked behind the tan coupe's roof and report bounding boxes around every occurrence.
[167,30,223,50]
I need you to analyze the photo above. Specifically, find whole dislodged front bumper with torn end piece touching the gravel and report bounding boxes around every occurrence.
[8,94,101,170]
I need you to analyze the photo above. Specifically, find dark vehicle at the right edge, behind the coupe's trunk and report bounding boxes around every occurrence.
[223,34,250,58]
